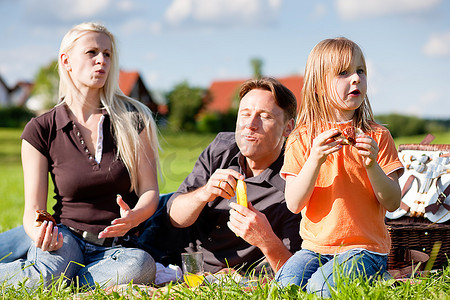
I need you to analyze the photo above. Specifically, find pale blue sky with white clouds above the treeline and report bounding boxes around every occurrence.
[0,0,450,118]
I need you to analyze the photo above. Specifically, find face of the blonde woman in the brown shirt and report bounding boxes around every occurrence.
[61,32,112,91]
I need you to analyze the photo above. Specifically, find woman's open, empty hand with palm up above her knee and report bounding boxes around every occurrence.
[98,195,139,239]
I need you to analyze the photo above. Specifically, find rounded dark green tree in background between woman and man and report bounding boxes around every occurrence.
[167,81,206,131]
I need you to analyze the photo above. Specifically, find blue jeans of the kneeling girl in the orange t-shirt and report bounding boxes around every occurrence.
[275,248,388,298]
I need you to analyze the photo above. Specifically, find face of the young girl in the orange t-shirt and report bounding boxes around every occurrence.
[327,55,367,121]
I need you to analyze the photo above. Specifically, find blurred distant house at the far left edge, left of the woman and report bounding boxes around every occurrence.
[0,76,34,106]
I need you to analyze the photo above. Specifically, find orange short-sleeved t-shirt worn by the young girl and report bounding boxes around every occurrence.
[281,123,403,254]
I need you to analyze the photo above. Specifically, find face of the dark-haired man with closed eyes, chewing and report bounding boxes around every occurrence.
[235,89,292,164]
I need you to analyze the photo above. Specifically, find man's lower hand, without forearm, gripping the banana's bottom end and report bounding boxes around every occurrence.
[227,202,277,248]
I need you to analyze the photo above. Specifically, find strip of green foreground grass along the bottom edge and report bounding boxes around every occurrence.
[0,267,450,300]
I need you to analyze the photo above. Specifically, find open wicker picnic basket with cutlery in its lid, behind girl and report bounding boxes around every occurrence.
[386,144,450,270]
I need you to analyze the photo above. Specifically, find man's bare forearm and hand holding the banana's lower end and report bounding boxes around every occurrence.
[228,202,292,272]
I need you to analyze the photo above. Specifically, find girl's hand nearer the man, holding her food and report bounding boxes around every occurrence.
[309,129,342,165]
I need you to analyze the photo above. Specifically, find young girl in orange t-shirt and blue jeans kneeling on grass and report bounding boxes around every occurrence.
[276,38,403,297]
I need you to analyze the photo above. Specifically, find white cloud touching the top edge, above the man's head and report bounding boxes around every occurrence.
[165,0,282,26]
